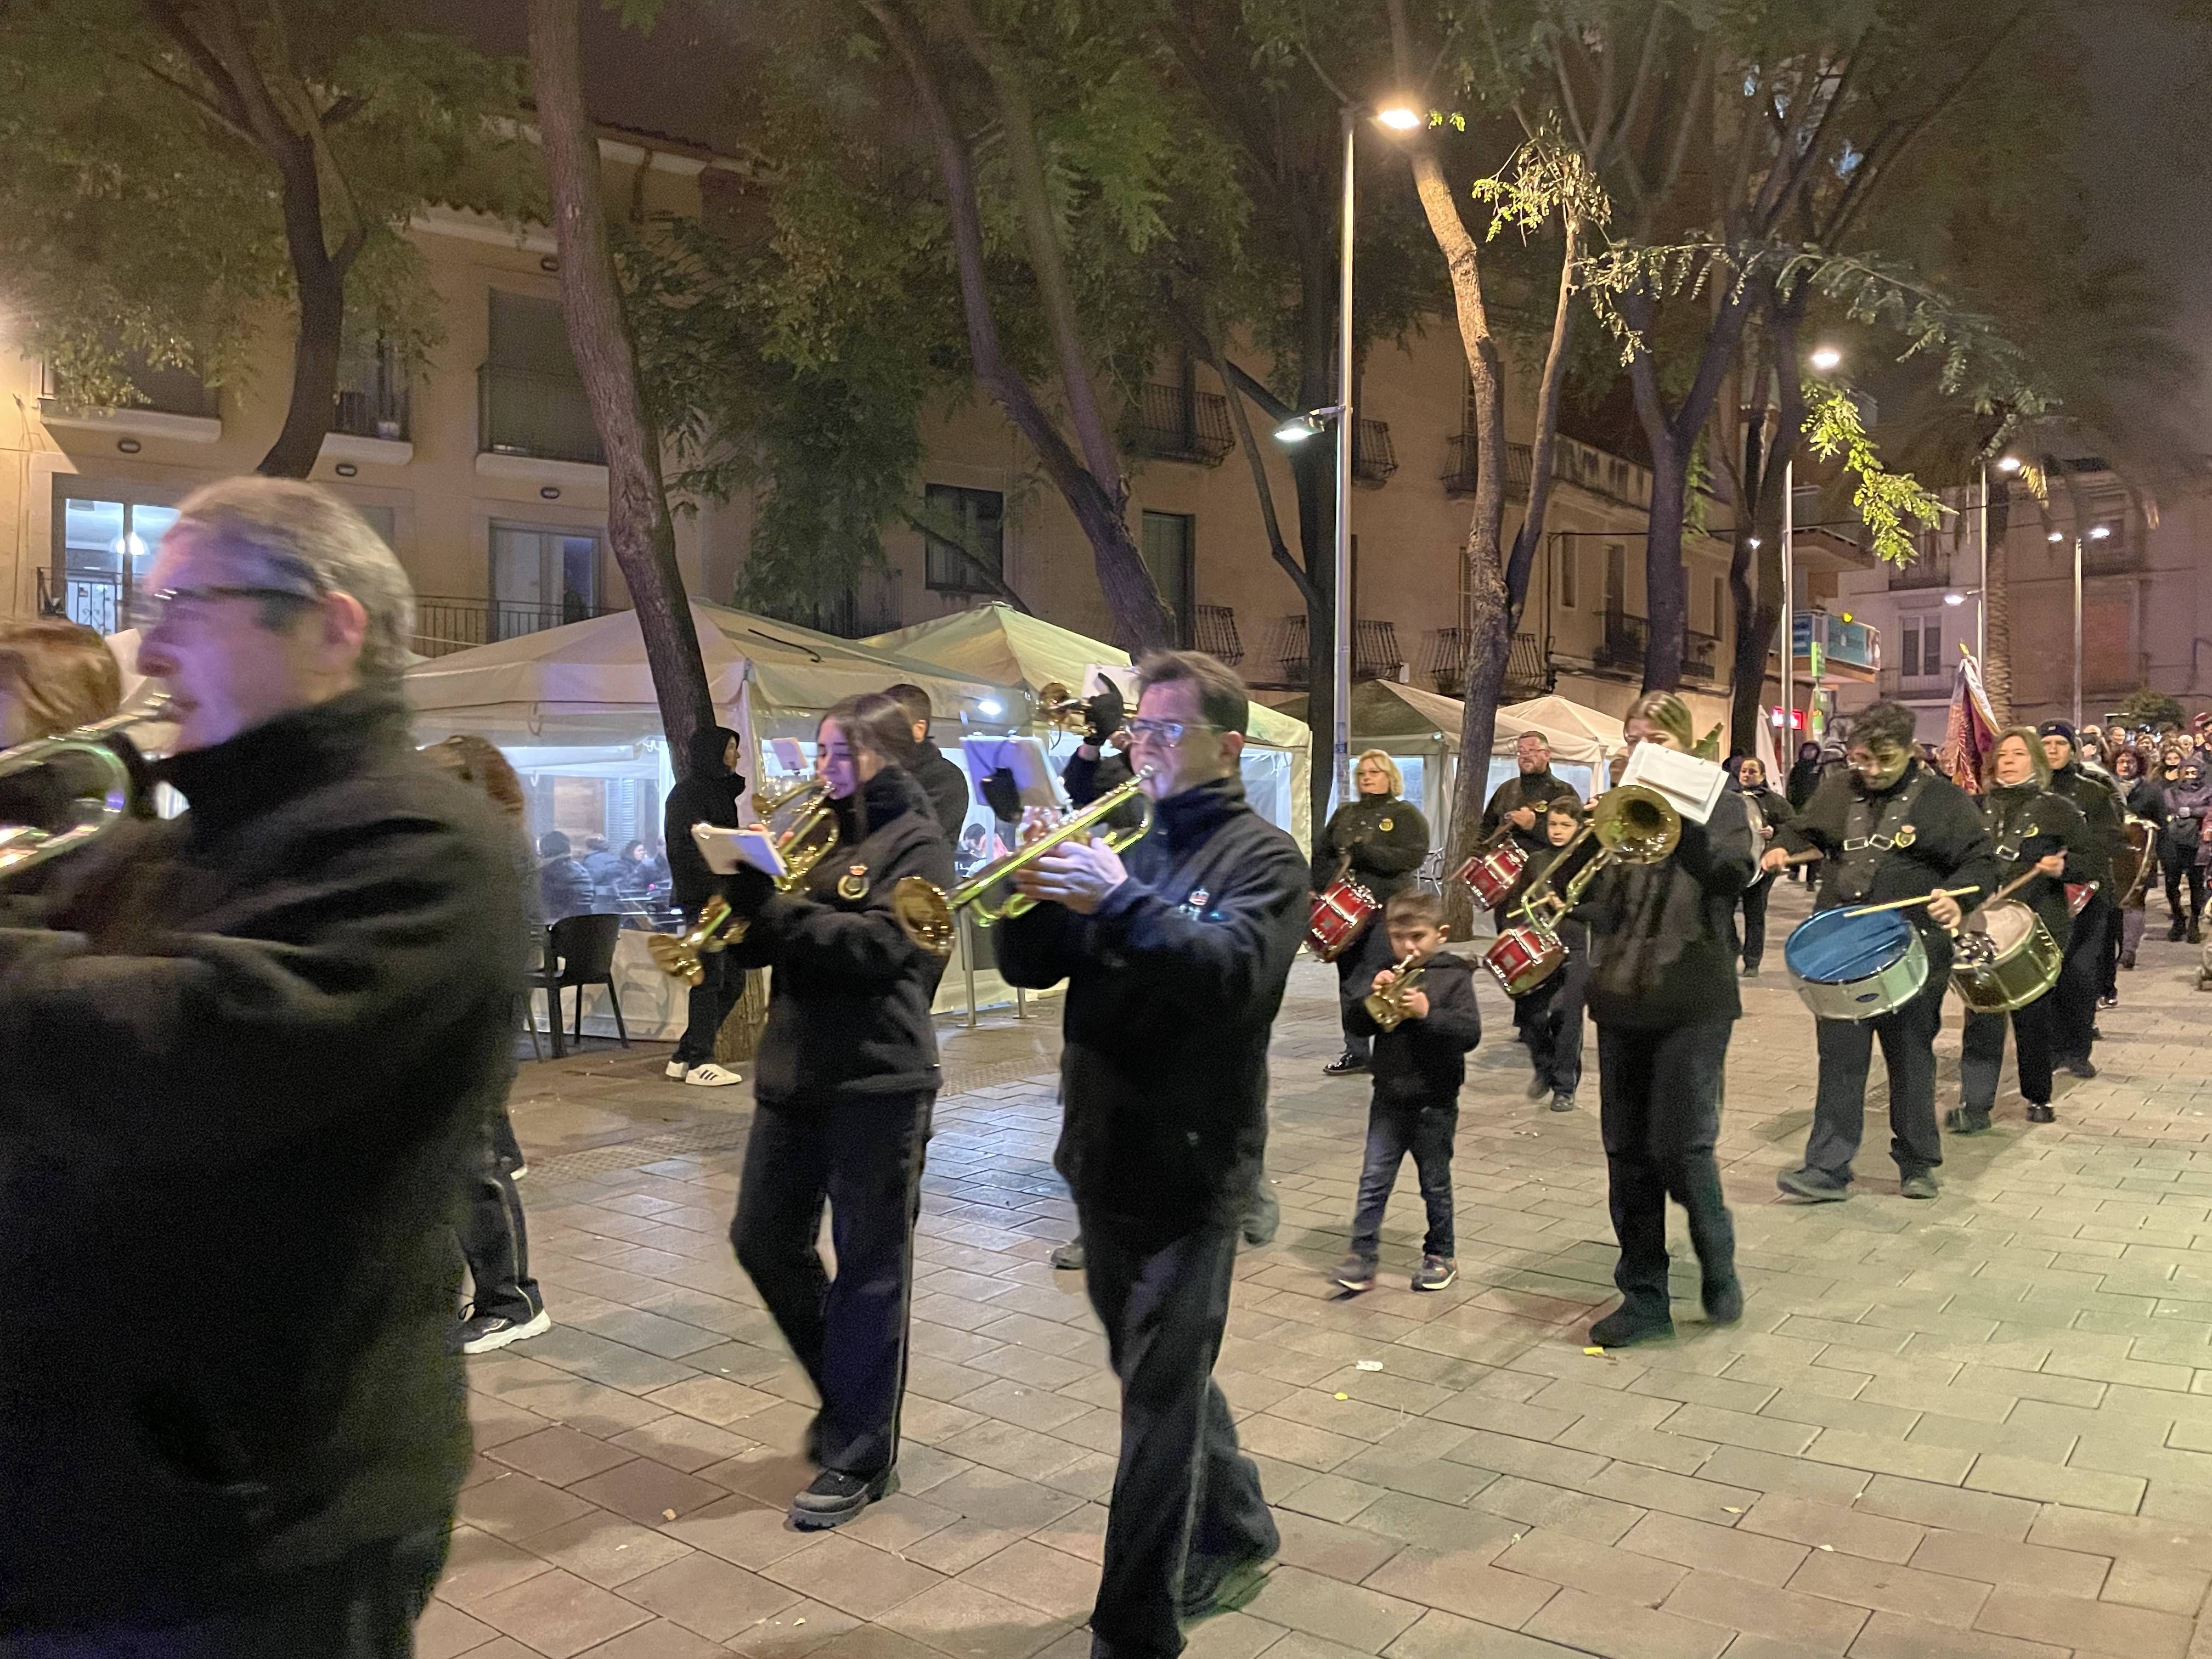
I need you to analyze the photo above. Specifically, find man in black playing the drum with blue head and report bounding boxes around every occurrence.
[1760,703,1997,1203]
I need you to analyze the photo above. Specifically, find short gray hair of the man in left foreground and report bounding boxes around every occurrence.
[175,476,414,686]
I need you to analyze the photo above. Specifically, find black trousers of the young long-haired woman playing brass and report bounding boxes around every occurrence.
[730,1091,936,1477]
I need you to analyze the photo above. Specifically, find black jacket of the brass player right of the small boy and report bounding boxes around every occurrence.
[1583,789,1758,1029]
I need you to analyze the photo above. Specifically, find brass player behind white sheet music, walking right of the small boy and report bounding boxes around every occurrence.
[1562,692,1754,1347]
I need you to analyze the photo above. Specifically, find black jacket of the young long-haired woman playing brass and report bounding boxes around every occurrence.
[730,765,953,1106]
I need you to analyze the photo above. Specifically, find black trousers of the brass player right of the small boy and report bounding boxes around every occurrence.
[1597,1020,1736,1314]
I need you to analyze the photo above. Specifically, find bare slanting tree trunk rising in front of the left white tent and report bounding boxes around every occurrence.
[529,0,714,772]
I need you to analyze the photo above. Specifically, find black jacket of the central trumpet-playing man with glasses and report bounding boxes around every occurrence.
[993,776,1307,1241]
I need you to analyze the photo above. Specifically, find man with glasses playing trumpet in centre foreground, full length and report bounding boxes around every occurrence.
[995,650,1305,1659]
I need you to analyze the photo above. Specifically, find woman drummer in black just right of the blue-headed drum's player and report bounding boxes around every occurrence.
[1944,725,2090,1135]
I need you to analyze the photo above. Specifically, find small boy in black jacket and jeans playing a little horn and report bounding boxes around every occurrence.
[1334,889,1482,1290]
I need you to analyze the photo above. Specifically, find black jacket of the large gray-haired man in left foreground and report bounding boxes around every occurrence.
[0,690,522,1630]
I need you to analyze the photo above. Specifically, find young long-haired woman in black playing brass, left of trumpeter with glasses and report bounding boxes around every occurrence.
[723,692,953,1528]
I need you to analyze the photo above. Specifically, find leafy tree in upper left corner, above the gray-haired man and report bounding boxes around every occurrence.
[0,0,535,478]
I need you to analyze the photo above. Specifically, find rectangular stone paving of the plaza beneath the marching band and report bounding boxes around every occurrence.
[436,889,2212,1659]
